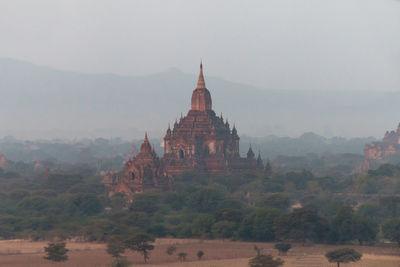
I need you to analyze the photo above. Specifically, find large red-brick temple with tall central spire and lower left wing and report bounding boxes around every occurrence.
[103,64,270,195]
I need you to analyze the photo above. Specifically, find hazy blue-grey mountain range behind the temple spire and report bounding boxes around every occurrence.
[0,58,400,138]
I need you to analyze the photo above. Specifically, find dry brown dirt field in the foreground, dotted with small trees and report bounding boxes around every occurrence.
[0,239,400,267]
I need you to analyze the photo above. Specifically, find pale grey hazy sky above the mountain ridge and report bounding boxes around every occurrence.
[0,0,400,90]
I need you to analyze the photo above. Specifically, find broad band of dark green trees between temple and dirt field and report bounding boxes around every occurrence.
[0,161,400,247]
